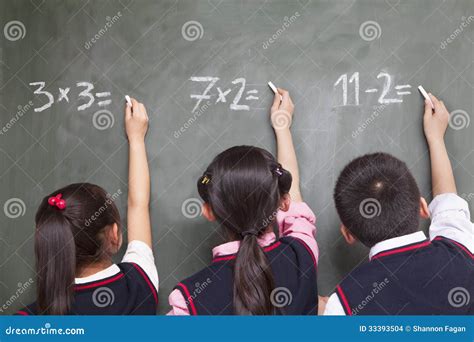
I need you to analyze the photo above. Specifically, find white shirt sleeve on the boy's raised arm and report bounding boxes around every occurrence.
[429,193,474,253]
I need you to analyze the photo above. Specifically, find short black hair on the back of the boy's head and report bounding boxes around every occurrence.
[334,153,420,247]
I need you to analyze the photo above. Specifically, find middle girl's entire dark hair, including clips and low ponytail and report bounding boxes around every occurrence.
[198,146,291,315]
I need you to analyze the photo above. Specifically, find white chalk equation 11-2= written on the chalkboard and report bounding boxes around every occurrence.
[334,72,411,106]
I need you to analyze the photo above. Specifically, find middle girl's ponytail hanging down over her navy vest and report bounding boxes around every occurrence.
[234,234,275,315]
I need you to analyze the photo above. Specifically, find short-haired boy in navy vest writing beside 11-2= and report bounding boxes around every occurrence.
[324,94,474,315]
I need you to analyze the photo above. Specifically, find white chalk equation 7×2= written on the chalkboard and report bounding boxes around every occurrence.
[190,76,258,113]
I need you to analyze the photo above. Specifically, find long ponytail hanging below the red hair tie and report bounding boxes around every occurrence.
[35,214,76,315]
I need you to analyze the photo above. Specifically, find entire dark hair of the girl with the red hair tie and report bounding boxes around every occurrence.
[35,183,120,315]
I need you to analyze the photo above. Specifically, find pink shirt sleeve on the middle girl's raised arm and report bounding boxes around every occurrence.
[277,202,319,263]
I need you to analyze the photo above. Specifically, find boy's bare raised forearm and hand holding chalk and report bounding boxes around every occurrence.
[423,94,456,197]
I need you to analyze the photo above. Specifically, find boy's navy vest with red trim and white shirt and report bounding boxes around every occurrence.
[324,193,474,315]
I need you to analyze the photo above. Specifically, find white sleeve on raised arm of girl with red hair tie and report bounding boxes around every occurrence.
[122,240,159,291]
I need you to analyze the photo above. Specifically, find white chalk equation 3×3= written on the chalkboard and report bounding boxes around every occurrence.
[29,81,112,113]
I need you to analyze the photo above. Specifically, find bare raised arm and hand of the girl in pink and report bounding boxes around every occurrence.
[270,89,303,202]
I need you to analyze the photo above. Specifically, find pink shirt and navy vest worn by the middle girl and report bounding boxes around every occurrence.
[168,202,319,315]
